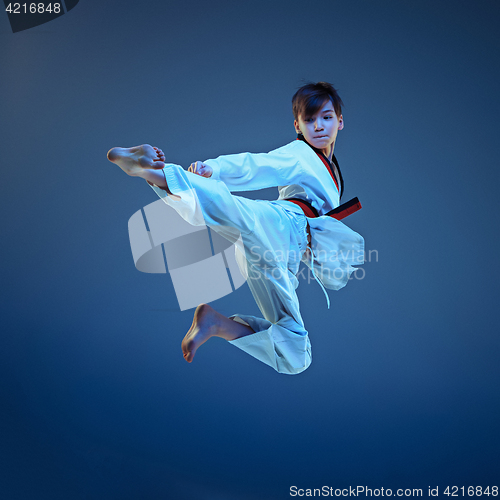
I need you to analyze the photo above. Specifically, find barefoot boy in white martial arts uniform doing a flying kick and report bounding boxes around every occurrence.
[108,82,364,374]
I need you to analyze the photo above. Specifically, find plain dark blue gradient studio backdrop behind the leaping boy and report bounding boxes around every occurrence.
[0,0,500,500]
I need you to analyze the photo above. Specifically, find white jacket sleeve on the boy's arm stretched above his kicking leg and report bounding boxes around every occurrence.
[204,150,303,191]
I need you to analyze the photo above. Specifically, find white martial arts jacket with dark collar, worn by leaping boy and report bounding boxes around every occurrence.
[204,140,364,290]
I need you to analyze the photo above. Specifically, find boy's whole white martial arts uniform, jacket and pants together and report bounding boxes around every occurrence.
[147,141,364,374]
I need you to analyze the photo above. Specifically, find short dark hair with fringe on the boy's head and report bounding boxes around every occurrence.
[292,82,344,120]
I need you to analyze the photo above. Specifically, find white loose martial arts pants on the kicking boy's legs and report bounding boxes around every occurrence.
[152,164,312,374]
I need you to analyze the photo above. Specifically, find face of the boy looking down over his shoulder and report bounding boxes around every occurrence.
[294,99,344,151]
